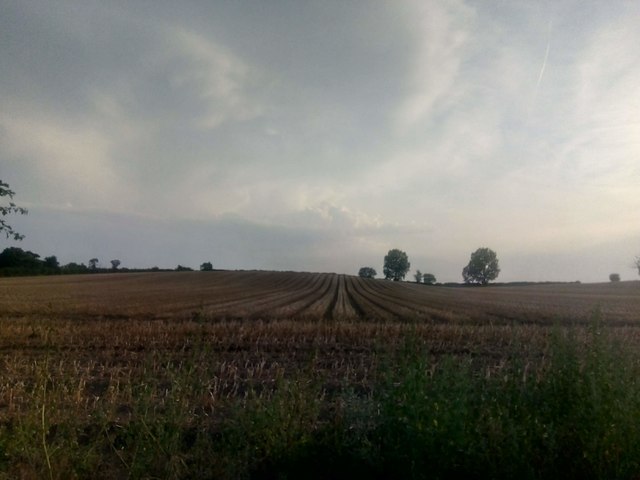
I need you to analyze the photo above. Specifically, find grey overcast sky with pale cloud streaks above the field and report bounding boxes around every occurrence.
[0,0,640,282]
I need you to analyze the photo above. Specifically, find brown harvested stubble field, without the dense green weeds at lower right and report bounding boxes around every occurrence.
[0,271,640,479]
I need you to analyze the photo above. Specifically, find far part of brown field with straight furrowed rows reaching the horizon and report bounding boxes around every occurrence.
[0,271,640,325]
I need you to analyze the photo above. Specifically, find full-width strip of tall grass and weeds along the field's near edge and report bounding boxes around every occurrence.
[0,315,640,479]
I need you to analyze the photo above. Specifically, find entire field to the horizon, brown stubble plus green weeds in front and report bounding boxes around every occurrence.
[0,271,640,478]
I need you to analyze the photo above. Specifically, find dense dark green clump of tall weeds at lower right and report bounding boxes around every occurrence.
[373,321,640,478]
